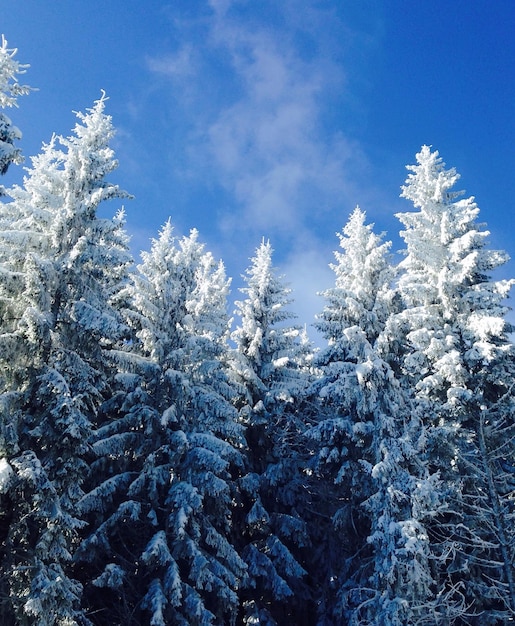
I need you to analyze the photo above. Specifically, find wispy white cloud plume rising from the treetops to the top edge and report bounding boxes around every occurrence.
[145,0,382,332]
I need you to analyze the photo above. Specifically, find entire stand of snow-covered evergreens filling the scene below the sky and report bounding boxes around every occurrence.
[0,39,515,626]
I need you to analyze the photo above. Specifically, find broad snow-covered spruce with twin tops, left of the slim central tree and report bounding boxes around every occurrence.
[81,222,246,625]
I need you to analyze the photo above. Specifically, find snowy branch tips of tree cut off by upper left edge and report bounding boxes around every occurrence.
[0,35,30,183]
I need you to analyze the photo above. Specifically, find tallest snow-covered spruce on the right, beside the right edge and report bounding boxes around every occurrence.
[389,146,515,624]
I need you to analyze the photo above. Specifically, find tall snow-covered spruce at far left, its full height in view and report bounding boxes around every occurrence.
[0,97,130,625]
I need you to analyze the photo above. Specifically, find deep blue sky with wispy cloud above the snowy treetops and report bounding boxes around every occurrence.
[0,0,515,332]
